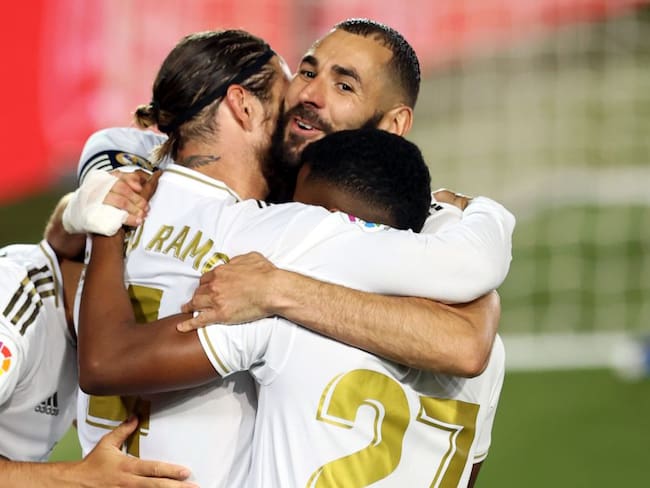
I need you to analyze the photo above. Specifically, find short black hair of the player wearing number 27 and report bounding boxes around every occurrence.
[300,128,431,232]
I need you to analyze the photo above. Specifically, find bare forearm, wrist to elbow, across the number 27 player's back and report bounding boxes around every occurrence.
[260,270,500,377]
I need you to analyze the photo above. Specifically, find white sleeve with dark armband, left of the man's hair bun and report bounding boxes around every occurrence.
[77,127,168,183]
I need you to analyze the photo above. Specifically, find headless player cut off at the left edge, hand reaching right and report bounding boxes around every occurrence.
[0,195,193,488]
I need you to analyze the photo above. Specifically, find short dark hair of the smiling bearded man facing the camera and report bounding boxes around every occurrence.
[334,19,421,108]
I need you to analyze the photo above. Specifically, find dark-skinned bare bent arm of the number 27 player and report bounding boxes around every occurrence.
[78,231,216,395]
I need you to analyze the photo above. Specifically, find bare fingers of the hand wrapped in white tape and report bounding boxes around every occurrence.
[102,170,157,227]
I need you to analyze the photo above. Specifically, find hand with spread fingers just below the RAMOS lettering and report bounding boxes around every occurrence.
[177,252,278,332]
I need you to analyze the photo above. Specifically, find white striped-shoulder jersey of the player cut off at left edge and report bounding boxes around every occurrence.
[0,241,78,461]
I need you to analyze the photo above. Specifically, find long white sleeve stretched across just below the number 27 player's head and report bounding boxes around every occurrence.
[176,198,514,302]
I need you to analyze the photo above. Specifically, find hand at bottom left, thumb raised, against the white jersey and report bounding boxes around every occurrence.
[76,417,198,488]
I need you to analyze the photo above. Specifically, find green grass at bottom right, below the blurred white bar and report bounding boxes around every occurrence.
[478,370,650,488]
